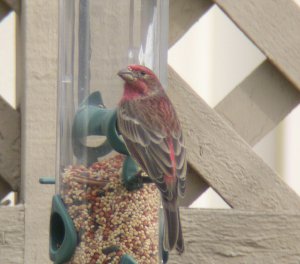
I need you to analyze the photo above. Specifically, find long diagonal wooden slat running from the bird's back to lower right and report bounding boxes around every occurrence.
[168,68,300,210]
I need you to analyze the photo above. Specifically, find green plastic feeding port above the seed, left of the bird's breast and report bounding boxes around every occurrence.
[72,91,128,165]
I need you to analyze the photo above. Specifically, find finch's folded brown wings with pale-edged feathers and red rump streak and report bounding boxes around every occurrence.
[118,101,186,200]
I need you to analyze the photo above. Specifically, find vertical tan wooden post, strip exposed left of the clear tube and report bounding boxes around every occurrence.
[20,0,58,264]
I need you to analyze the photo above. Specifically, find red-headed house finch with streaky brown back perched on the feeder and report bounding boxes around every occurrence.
[117,65,186,253]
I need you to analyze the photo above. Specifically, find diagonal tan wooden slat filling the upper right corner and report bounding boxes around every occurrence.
[214,0,300,89]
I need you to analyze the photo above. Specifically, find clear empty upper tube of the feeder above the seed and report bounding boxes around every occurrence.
[57,0,168,180]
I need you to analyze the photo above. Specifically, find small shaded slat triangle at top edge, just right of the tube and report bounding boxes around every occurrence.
[169,0,213,47]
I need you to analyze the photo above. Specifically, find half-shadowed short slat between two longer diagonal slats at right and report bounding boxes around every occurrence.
[214,61,300,146]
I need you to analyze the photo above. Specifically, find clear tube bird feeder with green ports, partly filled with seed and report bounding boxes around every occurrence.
[50,0,168,264]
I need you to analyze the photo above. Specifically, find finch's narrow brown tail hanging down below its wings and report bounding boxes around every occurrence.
[163,199,184,253]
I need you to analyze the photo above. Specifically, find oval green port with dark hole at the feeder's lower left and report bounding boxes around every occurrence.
[49,195,77,264]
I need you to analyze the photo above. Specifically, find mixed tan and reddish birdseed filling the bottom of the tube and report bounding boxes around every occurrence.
[60,154,160,264]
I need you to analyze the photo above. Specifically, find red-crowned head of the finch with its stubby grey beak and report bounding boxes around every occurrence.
[118,64,162,95]
